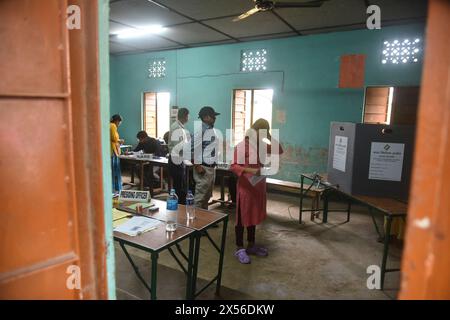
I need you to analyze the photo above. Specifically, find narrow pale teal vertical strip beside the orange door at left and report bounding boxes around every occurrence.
[98,0,116,300]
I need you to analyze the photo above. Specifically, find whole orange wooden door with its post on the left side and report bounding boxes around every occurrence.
[0,0,107,299]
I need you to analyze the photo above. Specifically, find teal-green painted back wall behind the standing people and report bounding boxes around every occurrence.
[111,24,424,181]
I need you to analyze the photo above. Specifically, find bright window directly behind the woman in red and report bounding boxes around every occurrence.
[232,89,273,145]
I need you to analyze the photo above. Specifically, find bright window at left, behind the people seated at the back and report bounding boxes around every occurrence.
[142,92,170,139]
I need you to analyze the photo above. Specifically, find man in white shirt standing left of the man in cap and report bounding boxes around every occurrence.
[168,108,190,204]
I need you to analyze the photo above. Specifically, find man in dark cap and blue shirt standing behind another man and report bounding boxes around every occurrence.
[192,106,220,209]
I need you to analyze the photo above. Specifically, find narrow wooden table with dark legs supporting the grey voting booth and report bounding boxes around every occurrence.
[299,174,408,290]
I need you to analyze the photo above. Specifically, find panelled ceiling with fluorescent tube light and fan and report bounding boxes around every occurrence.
[110,0,427,54]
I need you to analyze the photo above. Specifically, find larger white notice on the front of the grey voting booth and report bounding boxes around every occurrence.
[369,142,405,181]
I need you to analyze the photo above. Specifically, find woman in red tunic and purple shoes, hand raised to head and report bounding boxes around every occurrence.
[230,119,283,264]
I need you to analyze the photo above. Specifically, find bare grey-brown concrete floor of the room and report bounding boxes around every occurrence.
[116,174,402,300]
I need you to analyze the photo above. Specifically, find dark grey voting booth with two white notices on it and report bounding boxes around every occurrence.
[328,122,414,200]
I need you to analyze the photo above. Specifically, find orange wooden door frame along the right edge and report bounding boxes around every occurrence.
[399,0,450,299]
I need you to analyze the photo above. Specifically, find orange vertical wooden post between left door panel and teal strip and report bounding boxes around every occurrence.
[68,0,113,299]
